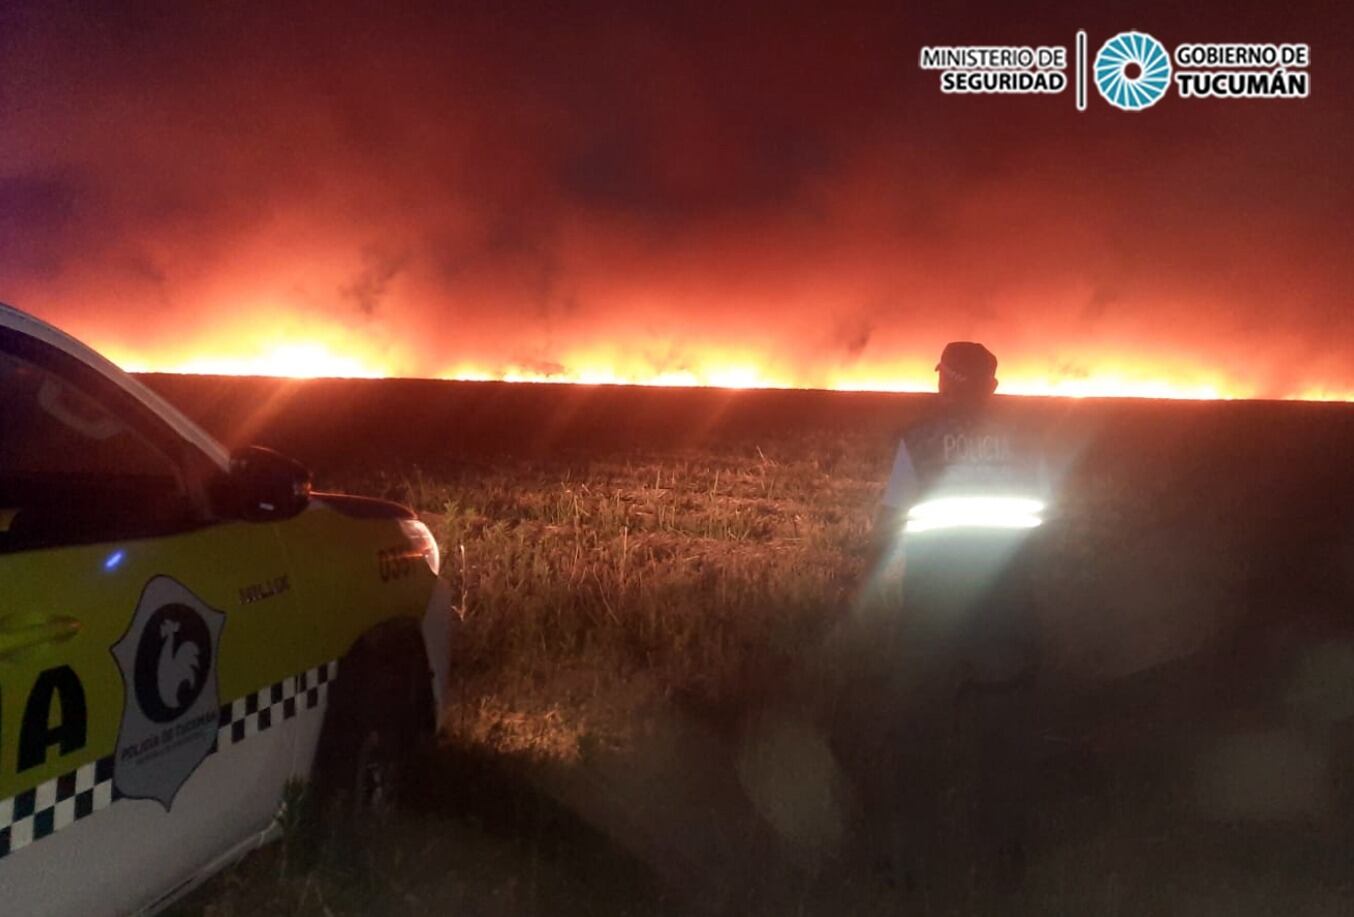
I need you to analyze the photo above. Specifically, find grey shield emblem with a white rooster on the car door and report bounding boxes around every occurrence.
[112,576,226,811]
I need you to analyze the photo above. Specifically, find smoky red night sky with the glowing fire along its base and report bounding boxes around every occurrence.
[0,0,1354,398]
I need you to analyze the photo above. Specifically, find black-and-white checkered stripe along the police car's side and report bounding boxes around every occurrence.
[0,661,339,859]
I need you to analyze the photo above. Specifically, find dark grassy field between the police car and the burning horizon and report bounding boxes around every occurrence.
[146,377,1354,914]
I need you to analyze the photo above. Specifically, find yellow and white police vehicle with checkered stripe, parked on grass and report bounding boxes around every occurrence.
[0,305,451,914]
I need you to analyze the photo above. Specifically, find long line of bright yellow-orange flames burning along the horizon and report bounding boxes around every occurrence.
[39,291,1332,401]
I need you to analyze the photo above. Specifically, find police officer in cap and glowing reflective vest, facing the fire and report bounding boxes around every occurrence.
[867,341,1047,884]
